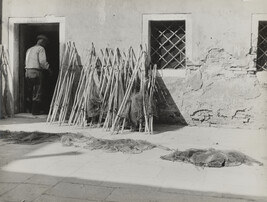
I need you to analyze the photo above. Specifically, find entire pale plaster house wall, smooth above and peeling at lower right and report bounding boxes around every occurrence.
[2,0,267,128]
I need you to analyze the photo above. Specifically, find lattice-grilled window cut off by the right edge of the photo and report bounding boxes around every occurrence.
[257,21,267,70]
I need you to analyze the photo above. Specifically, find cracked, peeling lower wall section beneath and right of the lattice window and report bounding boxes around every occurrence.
[161,49,267,128]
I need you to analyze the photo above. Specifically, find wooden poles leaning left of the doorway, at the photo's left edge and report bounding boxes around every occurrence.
[0,45,14,118]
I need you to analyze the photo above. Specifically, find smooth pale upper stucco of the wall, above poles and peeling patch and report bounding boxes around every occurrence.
[2,0,267,61]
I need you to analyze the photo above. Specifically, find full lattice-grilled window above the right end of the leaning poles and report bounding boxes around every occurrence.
[150,20,186,69]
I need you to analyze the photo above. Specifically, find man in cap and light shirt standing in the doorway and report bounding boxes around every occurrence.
[25,35,50,115]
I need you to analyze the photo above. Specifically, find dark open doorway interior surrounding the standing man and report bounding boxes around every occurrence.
[18,23,59,113]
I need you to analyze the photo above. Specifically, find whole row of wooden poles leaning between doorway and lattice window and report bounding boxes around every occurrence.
[48,44,157,133]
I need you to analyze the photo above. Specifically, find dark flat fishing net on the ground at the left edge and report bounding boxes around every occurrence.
[0,131,62,145]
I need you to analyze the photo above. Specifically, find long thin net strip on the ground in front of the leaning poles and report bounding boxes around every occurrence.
[61,134,170,154]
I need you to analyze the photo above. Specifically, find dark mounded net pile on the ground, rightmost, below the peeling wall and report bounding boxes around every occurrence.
[160,149,263,168]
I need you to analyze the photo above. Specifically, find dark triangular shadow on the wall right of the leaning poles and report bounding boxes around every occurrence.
[155,76,188,126]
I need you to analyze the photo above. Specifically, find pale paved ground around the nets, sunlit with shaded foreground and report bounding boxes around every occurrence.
[0,115,267,202]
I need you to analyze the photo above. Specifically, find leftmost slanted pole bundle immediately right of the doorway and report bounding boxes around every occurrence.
[47,42,81,124]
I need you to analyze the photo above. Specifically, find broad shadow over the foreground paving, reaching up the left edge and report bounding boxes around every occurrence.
[0,137,266,202]
